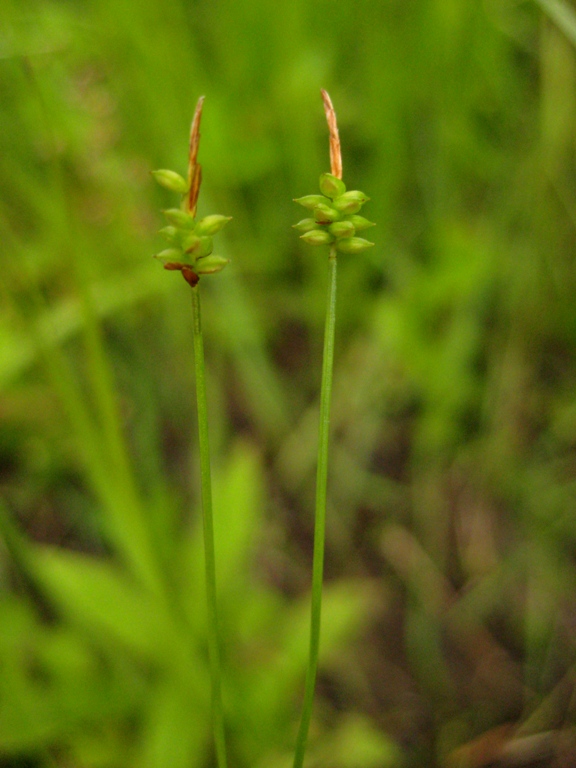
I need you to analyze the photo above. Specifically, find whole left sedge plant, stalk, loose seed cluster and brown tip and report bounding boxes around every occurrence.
[152,96,231,768]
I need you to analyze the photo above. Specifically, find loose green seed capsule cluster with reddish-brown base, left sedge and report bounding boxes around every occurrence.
[152,170,231,282]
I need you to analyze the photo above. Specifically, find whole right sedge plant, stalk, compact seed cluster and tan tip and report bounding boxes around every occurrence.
[294,90,374,768]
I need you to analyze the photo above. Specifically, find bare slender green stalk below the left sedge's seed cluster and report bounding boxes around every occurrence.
[192,285,227,768]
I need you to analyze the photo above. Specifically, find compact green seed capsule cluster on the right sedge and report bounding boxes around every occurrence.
[294,173,374,253]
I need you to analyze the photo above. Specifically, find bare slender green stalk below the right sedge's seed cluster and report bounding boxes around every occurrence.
[294,248,337,768]
